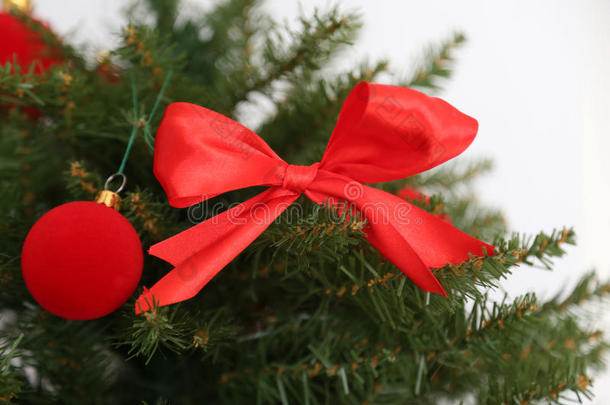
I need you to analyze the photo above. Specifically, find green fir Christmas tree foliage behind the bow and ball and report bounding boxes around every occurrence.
[0,0,610,405]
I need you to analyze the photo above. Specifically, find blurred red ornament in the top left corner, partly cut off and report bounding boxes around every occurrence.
[0,13,63,74]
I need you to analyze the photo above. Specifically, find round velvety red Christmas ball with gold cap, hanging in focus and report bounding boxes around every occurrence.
[21,190,143,320]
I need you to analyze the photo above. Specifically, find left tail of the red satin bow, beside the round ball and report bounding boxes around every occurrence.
[135,187,299,314]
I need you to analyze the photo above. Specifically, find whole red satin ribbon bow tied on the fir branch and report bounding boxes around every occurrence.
[136,82,493,312]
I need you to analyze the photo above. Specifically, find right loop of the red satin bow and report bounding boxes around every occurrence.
[320,82,478,183]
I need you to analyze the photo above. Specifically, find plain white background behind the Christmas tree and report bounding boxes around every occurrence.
[35,0,610,404]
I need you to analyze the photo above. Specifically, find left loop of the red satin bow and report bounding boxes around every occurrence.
[153,103,286,208]
